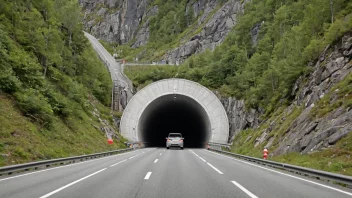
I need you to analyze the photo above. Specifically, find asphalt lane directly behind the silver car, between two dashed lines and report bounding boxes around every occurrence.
[136,149,248,198]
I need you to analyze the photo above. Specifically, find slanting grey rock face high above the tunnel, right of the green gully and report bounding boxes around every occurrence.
[165,0,248,64]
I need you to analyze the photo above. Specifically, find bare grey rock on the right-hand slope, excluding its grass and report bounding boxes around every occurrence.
[241,33,352,155]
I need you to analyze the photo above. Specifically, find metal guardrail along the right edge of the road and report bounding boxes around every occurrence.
[208,147,352,187]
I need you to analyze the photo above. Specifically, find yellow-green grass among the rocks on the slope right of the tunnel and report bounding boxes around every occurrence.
[231,74,352,176]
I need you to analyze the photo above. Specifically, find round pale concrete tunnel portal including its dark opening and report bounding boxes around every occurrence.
[120,78,229,147]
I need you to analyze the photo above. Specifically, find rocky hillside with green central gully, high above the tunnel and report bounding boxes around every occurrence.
[80,0,248,64]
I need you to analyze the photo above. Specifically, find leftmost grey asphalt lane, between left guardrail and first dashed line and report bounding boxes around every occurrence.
[0,150,147,198]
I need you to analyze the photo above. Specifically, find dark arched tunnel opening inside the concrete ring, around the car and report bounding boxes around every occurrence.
[138,94,211,148]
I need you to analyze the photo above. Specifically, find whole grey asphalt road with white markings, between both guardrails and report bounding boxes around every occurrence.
[0,148,352,198]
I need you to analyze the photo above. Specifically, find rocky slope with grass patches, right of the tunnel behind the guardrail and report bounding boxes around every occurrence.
[231,33,352,155]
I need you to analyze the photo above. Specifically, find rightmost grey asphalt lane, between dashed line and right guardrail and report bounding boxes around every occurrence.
[194,149,351,198]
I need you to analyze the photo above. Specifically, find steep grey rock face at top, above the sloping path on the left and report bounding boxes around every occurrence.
[79,0,153,46]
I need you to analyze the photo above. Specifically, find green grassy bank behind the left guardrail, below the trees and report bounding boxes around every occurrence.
[0,95,125,166]
